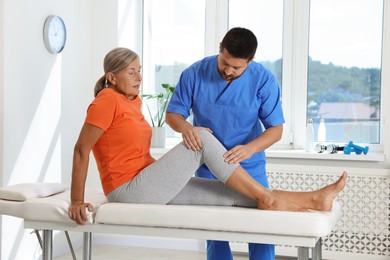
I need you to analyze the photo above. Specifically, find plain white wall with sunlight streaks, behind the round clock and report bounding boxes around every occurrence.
[0,0,118,259]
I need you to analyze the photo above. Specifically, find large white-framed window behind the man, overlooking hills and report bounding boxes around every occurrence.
[138,0,390,151]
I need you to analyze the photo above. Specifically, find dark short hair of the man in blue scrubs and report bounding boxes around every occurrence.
[220,27,257,61]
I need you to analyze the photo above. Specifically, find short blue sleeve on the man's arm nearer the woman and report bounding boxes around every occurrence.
[167,68,194,119]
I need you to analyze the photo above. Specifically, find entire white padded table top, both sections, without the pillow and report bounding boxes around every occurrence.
[0,186,340,237]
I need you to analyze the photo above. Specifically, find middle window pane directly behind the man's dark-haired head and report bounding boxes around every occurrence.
[229,0,283,86]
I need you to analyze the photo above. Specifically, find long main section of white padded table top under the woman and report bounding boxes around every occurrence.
[95,202,340,237]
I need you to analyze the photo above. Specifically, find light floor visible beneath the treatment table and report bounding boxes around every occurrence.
[54,245,291,260]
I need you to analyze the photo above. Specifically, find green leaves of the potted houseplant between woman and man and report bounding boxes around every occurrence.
[141,83,176,127]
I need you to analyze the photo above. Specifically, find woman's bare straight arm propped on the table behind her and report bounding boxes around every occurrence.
[68,123,104,224]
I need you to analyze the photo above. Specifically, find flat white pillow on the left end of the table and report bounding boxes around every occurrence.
[0,183,68,201]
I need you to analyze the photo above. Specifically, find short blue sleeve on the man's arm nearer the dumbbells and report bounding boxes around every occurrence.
[257,74,285,129]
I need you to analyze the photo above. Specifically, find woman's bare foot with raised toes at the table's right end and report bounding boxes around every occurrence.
[313,171,348,211]
